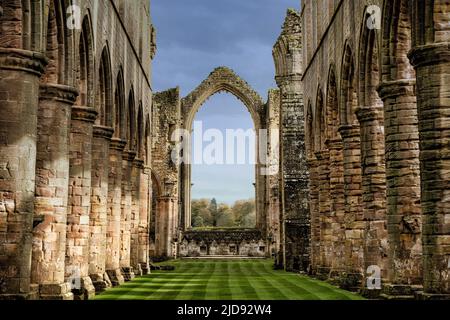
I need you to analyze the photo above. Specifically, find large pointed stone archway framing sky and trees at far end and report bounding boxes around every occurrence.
[180,67,266,258]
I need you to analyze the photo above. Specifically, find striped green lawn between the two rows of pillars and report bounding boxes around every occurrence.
[95,260,362,300]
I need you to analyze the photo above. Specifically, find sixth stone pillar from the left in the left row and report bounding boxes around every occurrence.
[120,150,136,281]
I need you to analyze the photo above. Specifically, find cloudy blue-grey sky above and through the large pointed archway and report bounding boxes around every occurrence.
[151,0,300,203]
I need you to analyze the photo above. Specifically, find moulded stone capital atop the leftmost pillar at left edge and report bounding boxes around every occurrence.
[0,48,48,77]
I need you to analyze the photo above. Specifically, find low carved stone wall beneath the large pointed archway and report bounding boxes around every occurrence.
[179,229,268,257]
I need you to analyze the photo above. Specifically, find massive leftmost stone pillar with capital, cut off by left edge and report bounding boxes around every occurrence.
[0,48,46,299]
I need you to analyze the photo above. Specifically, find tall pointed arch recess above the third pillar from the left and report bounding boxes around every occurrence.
[76,12,94,107]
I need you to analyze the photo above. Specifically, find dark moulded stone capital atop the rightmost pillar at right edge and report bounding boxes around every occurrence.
[408,42,450,69]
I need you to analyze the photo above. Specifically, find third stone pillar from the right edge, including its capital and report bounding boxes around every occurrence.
[356,106,388,296]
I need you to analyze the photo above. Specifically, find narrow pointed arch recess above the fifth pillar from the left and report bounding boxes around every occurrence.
[114,68,127,141]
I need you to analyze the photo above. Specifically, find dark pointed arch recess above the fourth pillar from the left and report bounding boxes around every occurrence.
[96,45,114,128]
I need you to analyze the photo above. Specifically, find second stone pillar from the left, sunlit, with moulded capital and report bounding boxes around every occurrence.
[32,84,78,299]
